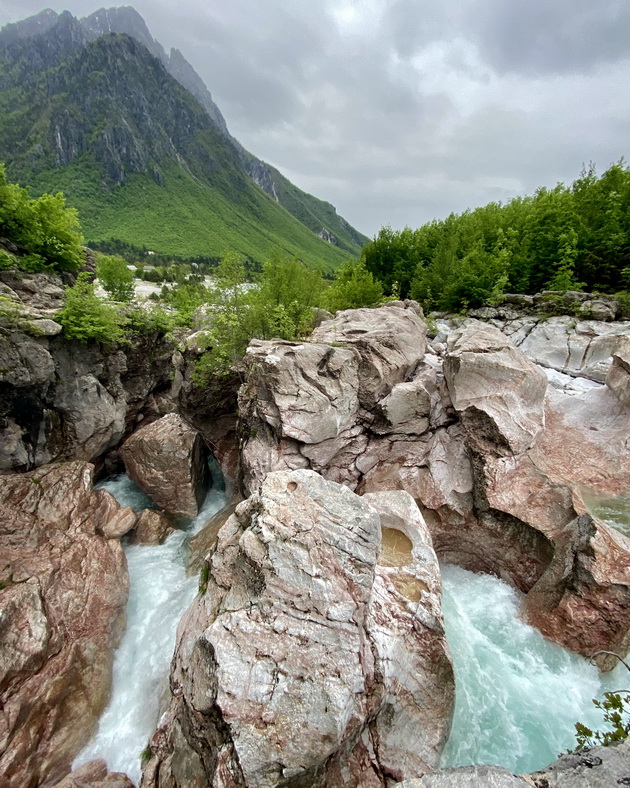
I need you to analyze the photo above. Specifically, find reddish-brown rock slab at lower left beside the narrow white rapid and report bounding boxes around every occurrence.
[0,462,128,788]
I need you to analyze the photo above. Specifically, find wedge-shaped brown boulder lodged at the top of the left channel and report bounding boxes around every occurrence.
[120,413,209,517]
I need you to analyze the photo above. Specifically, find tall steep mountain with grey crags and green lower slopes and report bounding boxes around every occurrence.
[0,7,367,269]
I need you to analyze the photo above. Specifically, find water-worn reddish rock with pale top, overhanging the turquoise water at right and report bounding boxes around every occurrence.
[436,322,630,668]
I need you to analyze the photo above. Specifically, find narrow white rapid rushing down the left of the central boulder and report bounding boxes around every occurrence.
[73,466,227,785]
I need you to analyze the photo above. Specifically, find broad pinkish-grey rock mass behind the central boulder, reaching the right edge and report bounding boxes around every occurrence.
[241,306,630,667]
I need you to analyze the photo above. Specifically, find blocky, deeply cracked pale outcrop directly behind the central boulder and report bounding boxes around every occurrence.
[239,302,436,492]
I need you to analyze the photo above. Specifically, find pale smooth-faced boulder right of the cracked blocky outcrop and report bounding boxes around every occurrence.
[444,321,547,454]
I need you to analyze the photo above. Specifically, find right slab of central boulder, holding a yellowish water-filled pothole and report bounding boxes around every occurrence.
[363,492,455,780]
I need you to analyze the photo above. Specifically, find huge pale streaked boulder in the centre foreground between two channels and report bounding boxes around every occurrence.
[142,470,454,788]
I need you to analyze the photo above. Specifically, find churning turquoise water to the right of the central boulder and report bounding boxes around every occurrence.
[441,566,630,773]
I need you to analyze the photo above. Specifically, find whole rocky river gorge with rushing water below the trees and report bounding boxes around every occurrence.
[0,274,630,788]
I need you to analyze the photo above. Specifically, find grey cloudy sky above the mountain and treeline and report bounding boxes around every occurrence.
[0,0,630,235]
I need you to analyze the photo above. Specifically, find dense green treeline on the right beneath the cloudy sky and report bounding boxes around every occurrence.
[362,160,630,309]
